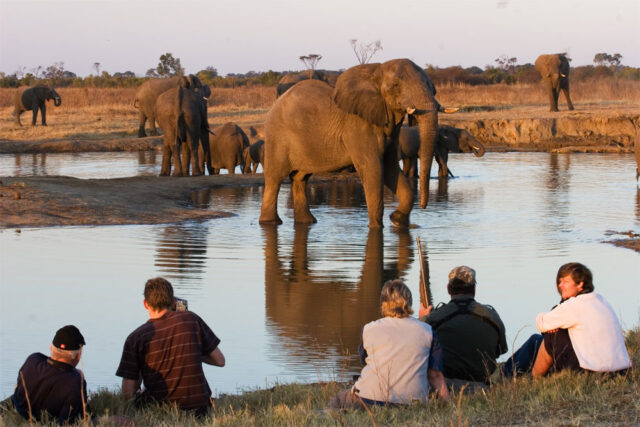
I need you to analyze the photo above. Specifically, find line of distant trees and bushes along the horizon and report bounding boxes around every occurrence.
[0,51,640,88]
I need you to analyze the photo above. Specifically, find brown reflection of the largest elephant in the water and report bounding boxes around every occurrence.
[263,224,413,372]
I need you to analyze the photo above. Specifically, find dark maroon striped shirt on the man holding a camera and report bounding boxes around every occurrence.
[116,311,220,410]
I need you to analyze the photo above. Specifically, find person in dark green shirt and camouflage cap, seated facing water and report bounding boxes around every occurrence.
[420,265,507,385]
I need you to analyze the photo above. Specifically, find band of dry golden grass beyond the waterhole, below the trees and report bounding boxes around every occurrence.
[0,79,640,141]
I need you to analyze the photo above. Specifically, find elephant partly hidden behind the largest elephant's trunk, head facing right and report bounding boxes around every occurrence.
[398,125,485,178]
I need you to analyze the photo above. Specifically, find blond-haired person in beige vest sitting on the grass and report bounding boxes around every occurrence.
[329,279,449,409]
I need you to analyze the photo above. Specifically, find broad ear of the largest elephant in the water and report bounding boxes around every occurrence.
[333,64,387,127]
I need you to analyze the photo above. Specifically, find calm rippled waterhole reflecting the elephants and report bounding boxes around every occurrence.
[0,153,640,397]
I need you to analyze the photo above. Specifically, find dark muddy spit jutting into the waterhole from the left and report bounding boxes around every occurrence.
[0,175,264,228]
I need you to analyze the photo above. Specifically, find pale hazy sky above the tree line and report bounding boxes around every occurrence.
[0,0,640,76]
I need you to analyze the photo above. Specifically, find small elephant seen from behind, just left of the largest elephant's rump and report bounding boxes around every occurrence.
[201,122,249,175]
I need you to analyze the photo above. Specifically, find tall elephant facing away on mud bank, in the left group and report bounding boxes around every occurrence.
[154,86,210,176]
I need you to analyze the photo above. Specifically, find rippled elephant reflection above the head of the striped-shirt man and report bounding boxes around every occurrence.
[154,223,208,279]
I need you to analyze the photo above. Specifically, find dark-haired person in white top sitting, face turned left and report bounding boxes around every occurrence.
[502,262,631,377]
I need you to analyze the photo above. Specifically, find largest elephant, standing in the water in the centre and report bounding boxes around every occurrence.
[260,59,440,228]
